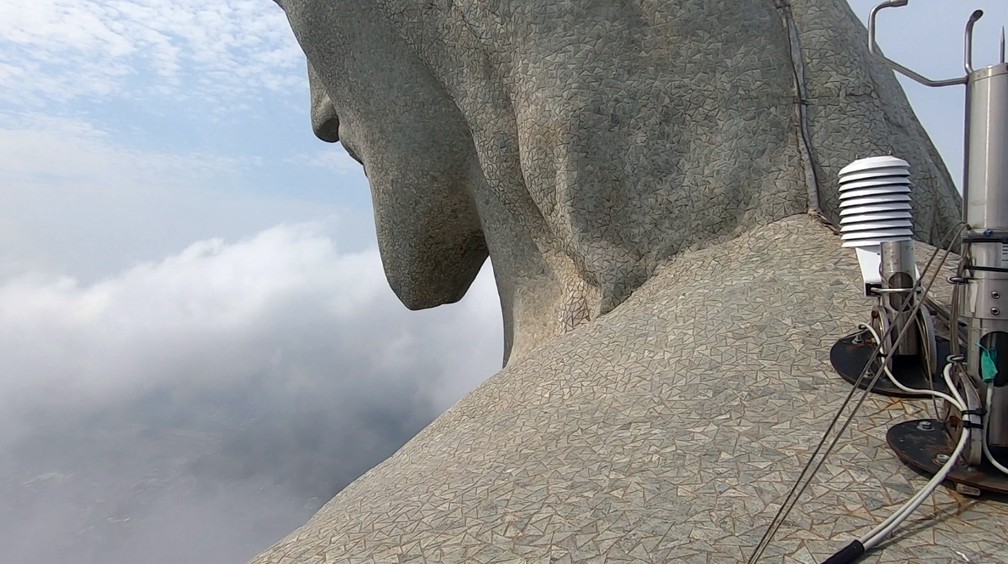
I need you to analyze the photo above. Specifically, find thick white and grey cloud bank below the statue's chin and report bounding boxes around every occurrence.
[0,225,501,563]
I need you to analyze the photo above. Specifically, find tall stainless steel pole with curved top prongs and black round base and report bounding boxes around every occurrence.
[868,0,1008,494]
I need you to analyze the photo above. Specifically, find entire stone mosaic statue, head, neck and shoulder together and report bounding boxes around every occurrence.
[257,0,1006,563]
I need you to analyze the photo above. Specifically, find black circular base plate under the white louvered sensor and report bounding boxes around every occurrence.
[830,331,950,398]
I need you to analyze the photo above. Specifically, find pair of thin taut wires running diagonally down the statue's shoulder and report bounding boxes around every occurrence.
[748,222,966,564]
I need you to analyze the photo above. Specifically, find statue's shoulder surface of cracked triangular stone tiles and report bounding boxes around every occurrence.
[253,216,1008,564]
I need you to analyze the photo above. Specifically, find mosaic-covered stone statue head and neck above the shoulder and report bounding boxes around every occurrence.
[278,0,958,358]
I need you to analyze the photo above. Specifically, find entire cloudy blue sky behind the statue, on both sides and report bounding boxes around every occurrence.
[0,0,1008,564]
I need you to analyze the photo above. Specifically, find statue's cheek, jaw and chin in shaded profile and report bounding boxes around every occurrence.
[281,0,488,309]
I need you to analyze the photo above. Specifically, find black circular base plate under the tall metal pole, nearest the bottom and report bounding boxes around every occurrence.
[885,419,1008,495]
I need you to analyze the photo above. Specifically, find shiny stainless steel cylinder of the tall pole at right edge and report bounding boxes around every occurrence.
[963,63,1008,446]
